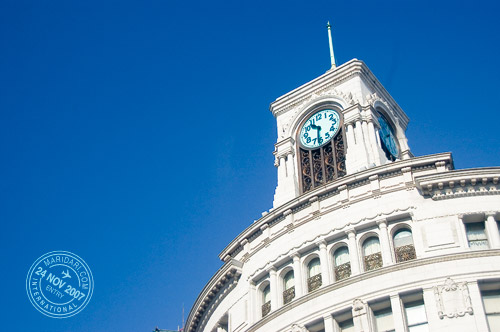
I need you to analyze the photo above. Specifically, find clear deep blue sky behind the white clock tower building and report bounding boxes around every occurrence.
[0,0,500,332]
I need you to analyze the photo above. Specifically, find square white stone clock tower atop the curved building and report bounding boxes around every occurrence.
[270,59,412,208]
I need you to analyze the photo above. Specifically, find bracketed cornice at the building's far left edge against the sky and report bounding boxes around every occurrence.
[185,259,243,332]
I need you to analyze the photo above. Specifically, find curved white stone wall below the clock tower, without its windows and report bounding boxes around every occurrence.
[187,155,500,332]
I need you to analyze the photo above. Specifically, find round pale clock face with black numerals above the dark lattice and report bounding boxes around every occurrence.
[300,109,340,149]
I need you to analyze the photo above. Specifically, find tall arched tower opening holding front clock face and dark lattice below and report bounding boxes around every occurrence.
[297,108,346,193]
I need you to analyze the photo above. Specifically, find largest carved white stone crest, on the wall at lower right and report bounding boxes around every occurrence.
[434,278,474,319]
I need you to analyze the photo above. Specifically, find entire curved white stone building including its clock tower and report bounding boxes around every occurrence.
[185,59,500,332]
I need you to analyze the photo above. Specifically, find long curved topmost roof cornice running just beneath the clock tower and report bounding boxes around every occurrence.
[219,153,453,261]
